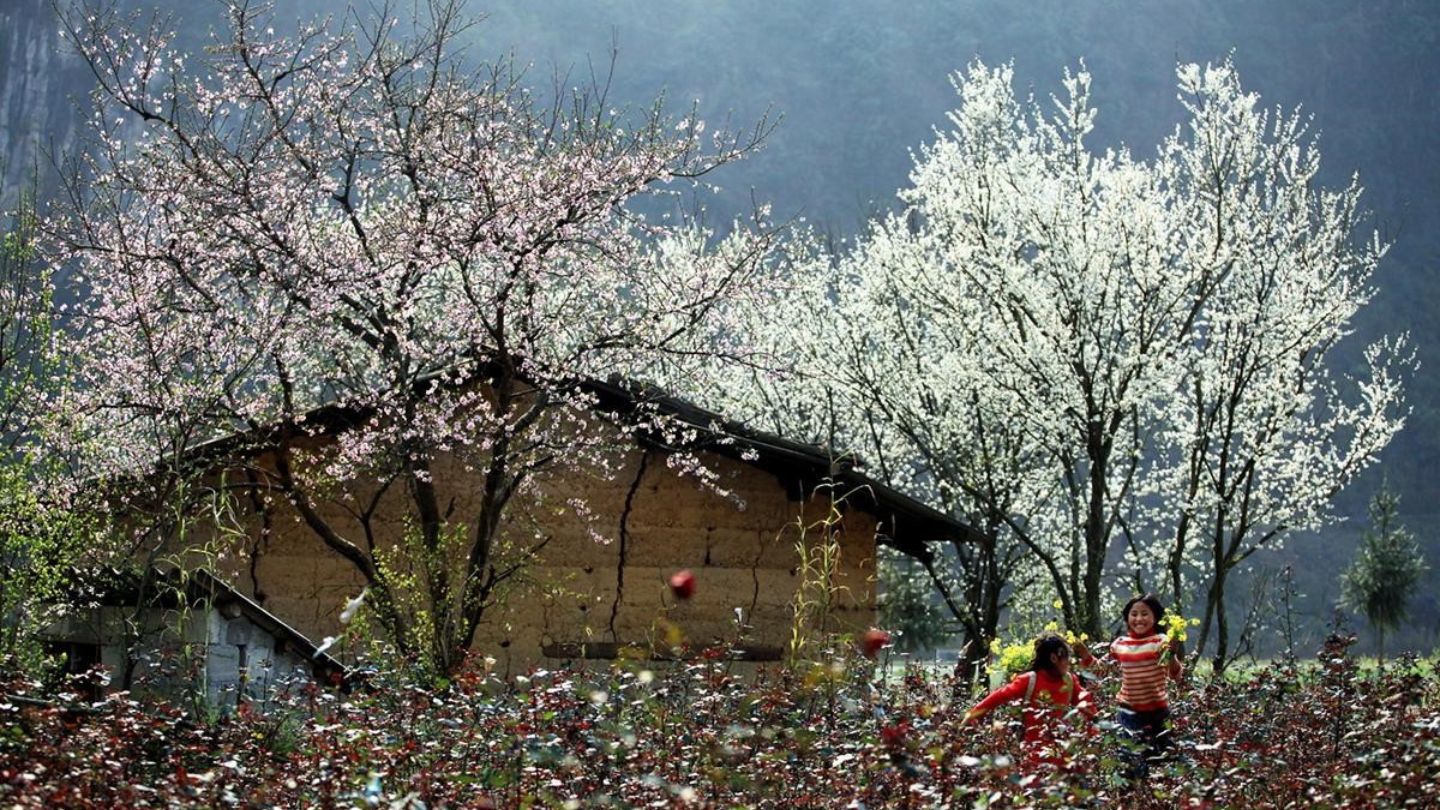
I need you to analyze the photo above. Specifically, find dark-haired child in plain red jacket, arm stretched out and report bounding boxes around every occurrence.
[965,633,1096,767]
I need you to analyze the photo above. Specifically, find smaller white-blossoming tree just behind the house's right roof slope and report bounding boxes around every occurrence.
[708,198,1051,679]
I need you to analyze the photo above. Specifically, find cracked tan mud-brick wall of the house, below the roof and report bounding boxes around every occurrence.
[203,448,876,672]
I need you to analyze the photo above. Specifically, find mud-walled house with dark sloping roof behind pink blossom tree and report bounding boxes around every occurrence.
[137,380,969,670]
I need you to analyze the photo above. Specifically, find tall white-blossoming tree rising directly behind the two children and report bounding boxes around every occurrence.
[720,63,1188,639]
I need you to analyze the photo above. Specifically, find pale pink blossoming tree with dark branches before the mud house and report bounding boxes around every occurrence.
[50,0,775,669]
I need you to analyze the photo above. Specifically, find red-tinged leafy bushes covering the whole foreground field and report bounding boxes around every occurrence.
[0,648,1440,809]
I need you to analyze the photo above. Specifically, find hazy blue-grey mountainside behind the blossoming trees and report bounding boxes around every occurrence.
[0,0,1440,650]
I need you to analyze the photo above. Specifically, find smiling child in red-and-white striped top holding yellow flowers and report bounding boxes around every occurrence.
[1076,594,1184,775]
